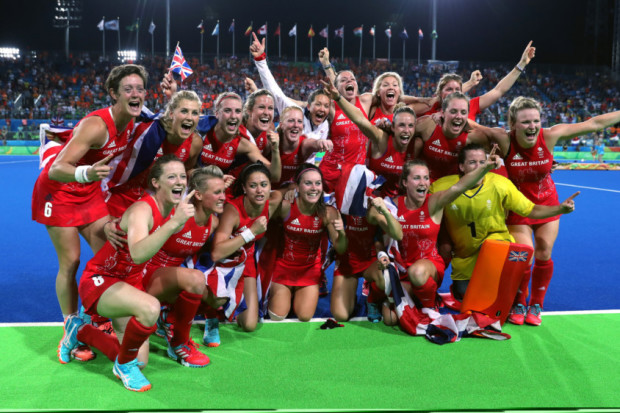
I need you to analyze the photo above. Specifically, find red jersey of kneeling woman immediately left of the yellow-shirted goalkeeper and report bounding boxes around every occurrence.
[389,195,445,277]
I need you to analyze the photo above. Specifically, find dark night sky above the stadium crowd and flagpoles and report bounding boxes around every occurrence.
[0,0,613,65]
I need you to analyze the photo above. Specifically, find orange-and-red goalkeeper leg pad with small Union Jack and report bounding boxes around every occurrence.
[461,240,534,324]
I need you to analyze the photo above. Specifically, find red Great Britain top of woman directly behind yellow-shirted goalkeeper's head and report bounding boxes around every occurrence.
[421,125,467,182]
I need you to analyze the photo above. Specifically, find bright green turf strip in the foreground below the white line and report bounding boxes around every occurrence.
[0,314,620,411]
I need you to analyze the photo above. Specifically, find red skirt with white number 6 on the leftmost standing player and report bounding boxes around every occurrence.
[32,170,108,227]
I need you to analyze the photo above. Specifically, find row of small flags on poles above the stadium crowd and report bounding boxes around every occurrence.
[97,19,438,40]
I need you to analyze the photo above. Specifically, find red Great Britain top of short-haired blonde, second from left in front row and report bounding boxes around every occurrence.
[144,215,213,285]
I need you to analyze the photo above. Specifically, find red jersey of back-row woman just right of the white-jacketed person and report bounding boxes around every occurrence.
[319,97,368,189]
